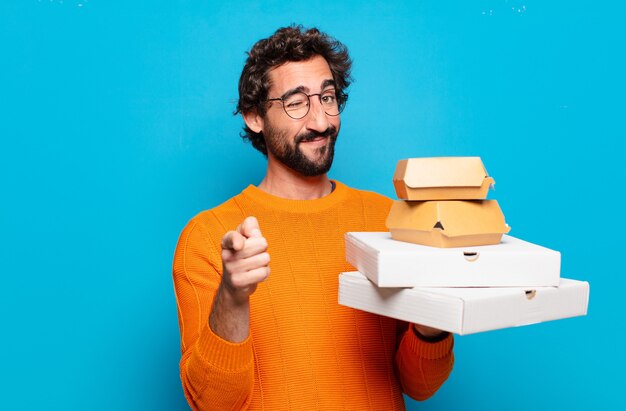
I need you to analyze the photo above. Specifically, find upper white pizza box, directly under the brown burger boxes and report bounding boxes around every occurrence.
[345,232,561,287]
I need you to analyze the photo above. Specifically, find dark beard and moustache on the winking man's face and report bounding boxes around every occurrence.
[265,126,339,177]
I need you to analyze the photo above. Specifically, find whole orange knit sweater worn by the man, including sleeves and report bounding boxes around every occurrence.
[174,182,453,411]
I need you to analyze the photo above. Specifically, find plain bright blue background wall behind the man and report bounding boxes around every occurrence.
[0,0,626,411]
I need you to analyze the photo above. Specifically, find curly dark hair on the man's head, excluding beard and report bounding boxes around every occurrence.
[235,25,352,156]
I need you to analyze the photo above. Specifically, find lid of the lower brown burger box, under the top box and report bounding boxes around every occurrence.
[386,200,511,237]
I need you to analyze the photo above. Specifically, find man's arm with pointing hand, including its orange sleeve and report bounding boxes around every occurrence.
[174,219,269,410]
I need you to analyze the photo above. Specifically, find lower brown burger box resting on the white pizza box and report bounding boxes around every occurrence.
[387,200,511,248]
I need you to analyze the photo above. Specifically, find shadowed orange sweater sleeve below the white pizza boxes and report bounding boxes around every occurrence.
[396,323,454,401]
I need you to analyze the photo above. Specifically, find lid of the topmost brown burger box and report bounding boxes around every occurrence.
[393,157,495,188]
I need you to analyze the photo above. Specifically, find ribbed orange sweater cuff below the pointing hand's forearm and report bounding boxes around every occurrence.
[197,324,254,372]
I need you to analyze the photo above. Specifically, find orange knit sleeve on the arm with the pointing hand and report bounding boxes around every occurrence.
[173,220,254,410]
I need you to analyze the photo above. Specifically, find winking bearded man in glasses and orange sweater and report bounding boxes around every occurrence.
[173,26,454,411]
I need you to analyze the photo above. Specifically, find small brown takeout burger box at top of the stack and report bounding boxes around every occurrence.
[393,157,495,200]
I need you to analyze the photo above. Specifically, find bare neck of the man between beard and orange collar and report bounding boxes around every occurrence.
[259,161,333,200]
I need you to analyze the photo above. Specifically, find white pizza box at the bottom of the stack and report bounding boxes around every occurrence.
[339,272,589,335]
